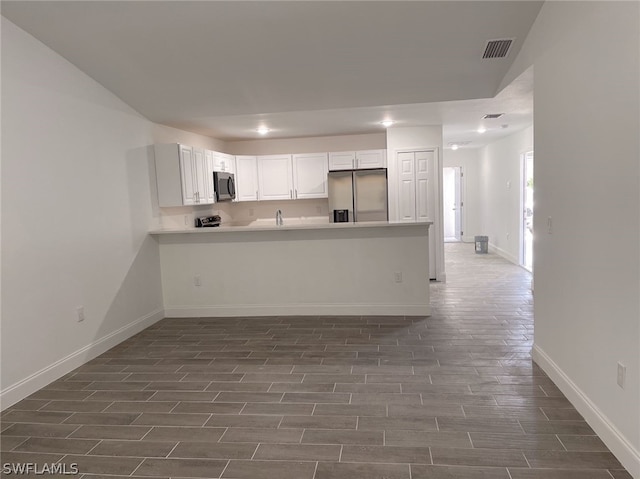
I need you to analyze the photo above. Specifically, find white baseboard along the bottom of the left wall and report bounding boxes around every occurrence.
[0,309,165,409]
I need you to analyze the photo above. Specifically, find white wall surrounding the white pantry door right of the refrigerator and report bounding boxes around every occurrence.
[387,125,446,280]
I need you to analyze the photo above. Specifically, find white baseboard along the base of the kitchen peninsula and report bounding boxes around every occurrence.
[164,304,431,318]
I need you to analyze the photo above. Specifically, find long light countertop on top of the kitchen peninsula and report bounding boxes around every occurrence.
[149,219,433,235]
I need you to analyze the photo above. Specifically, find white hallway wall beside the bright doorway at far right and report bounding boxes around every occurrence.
[480,127,535,264]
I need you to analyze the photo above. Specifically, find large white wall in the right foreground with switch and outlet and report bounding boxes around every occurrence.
[509,2,640,478]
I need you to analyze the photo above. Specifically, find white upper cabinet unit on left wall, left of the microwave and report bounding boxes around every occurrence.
[155,143,213,207]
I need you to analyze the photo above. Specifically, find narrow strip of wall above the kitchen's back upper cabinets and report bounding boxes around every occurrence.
[225,132,387,155]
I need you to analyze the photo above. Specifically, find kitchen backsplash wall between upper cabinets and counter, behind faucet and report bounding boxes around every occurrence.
[151,198,329,229]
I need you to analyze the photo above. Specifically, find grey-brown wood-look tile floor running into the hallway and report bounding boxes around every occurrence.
[1,243,631,479]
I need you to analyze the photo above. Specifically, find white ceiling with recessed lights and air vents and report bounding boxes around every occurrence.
[1,0,542,147]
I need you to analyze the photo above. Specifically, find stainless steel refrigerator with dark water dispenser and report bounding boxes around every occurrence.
[328,168,389,223]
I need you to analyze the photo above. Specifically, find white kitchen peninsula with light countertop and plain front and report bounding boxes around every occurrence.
[151,221,431,317]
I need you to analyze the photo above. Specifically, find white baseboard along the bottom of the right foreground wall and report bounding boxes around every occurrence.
[532,344,640,478]
